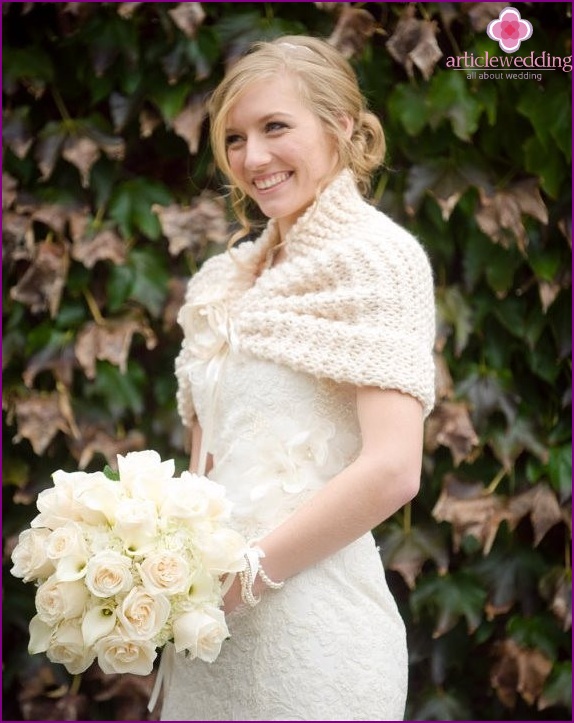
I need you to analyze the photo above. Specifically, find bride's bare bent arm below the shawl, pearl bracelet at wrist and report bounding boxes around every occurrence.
[225,387,423,612]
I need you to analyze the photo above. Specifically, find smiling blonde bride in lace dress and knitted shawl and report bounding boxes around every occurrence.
[161,36,434,721]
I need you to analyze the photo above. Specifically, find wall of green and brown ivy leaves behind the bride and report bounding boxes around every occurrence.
[2,2,572,720]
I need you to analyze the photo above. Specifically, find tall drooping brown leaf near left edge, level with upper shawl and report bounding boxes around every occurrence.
[10,241,70,318]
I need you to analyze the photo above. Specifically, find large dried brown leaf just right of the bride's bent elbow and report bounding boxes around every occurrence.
[432,475,505,554]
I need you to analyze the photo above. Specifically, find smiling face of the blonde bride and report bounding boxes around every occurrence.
[225,74,337,238]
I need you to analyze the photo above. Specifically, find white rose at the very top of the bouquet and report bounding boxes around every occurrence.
[118,449,175,506]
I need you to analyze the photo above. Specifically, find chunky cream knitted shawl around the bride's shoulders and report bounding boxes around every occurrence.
[176,171,435,425]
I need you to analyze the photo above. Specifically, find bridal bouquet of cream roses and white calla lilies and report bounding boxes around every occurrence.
[11,450,247,675]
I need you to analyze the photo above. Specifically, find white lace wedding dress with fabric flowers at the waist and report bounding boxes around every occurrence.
[161,346,407,721]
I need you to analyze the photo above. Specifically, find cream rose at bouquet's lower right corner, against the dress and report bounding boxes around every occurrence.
[173,608,229,663]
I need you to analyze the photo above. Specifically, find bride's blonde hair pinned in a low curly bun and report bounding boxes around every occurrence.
[209,35,385,240]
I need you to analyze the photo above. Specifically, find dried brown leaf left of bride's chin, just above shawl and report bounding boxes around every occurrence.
[152,192,232,256]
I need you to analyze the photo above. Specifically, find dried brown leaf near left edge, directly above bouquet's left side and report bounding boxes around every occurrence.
[13,392,75,455]
